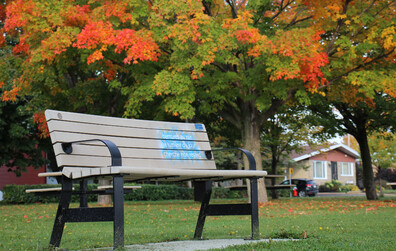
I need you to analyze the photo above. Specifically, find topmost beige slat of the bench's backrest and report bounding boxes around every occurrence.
[45,110,206,131]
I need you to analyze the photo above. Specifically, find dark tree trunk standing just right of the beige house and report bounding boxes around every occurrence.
[356,128,378,200]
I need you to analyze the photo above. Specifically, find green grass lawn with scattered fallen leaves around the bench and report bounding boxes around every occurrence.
[0,196,396,250]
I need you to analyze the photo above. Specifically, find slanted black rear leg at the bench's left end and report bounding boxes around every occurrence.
[50,177,73,247]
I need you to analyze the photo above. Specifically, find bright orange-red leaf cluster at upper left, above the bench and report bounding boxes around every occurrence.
[4,0,159,64]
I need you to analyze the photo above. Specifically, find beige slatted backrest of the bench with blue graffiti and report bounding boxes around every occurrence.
[45,110,216,169]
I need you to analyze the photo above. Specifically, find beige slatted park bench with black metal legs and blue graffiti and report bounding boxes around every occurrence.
[41,110,267,248]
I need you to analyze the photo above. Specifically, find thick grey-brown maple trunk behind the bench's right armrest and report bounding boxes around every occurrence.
[242,109,268,203]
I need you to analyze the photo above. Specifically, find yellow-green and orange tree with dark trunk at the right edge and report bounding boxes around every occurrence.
[305,0,396,199]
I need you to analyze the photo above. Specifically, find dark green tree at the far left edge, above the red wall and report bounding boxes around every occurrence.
[0,5,46,176]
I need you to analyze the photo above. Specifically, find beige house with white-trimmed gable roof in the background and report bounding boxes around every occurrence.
[291,144,360,185]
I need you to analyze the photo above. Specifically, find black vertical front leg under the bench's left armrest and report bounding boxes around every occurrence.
[113,176,124,248]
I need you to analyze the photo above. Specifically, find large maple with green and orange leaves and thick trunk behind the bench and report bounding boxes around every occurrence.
[127,1,327,201]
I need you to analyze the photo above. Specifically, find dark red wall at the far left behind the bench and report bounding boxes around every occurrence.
[0,166,45,190]
